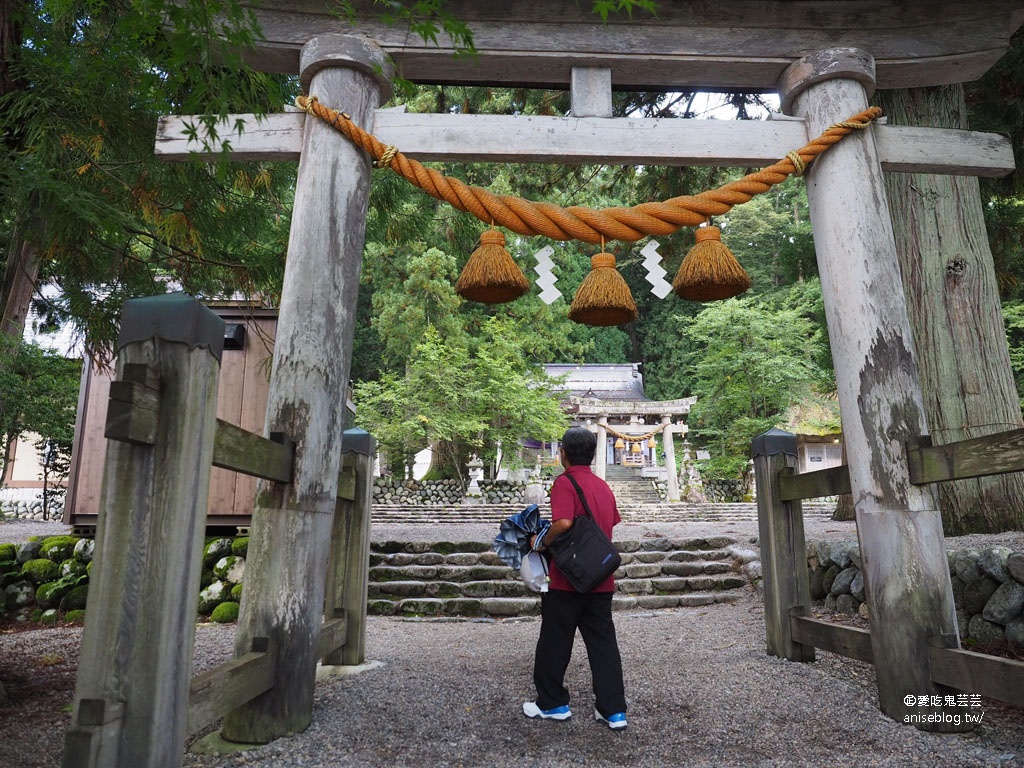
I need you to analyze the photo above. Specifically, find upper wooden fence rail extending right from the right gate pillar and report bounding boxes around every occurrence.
[906,429,1024,484]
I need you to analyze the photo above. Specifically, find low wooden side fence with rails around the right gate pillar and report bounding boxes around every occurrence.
[752,429,1024,720]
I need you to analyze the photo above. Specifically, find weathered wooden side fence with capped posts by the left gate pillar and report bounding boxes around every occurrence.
[63,294,375,768]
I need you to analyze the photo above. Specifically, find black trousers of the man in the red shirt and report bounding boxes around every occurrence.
[534,590,626,717]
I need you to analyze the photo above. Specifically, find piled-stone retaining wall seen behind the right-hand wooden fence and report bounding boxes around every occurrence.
[807,542,1024,647]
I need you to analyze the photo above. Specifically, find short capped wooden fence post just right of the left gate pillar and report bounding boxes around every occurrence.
[324,429,377,665]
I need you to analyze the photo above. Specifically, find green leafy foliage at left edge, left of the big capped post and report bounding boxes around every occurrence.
[0,337,82,487]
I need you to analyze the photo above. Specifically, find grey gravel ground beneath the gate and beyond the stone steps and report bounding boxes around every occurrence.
[0,520,1024,768]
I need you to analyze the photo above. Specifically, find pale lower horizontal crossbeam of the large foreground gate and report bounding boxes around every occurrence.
[155,110,1015,176]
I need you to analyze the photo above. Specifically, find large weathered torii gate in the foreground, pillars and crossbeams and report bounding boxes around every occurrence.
[157,0,1024,742]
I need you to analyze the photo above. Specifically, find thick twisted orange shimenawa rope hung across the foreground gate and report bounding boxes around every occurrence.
[296,96,882,244]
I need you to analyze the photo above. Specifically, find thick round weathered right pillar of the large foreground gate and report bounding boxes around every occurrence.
[779,48,970,731]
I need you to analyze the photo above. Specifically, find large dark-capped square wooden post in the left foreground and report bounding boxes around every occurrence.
[63,294,224,768]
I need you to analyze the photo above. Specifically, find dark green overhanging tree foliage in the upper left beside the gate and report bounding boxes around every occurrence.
[0,0,295,356]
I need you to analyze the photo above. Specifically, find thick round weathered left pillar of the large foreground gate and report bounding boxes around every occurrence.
[222,35,390,743]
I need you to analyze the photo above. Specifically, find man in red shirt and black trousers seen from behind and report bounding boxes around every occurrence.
[522,427,626,730]
